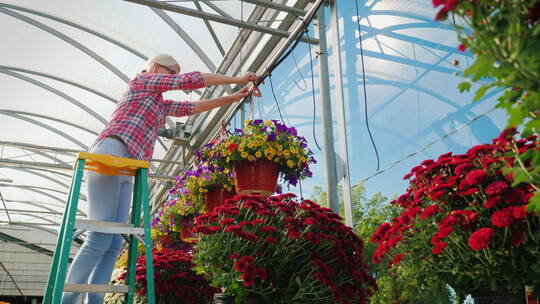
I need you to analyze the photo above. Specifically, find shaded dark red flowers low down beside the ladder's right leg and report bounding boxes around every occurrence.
[120,249,219,304]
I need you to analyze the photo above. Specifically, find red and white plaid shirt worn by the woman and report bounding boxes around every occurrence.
[93,72,204,161]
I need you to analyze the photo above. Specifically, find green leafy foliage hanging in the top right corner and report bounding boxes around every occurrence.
[434,0,540,212]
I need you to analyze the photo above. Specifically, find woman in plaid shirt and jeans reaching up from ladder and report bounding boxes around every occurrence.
[62,55,260,304]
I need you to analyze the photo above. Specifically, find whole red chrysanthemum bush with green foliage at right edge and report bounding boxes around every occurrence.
[371,130,540,303]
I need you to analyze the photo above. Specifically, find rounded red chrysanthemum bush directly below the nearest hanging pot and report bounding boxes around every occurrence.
[194,194,376,303]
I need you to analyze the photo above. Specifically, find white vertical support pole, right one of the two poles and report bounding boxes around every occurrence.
[330,1,353,227]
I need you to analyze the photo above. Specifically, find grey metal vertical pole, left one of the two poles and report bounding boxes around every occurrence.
[313,7,339,213]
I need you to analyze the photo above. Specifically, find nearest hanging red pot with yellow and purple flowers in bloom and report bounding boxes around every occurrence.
[209,120,316,196]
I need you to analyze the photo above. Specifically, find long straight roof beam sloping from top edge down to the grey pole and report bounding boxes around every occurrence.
[125,0,318,44]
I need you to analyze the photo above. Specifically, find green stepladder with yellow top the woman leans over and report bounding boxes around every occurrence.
[43,152,155,304]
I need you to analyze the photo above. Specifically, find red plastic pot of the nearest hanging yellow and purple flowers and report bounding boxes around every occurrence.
[234,160,279,197]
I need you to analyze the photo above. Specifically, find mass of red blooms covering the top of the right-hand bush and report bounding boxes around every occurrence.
[371,128,536,264]
